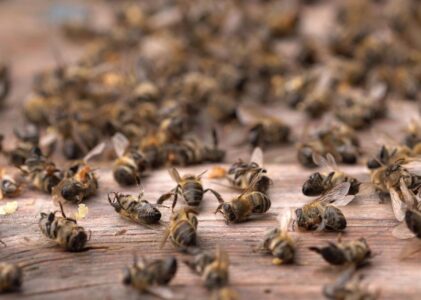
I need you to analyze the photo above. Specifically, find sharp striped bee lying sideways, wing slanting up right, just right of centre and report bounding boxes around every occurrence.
[215,174,271,223]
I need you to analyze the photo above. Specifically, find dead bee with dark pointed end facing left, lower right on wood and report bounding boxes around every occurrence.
[309,236,372,267]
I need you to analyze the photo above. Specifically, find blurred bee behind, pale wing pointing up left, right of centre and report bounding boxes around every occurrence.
[237,106,291,147]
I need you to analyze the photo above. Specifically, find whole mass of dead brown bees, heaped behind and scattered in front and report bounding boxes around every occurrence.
[0,0,421,299]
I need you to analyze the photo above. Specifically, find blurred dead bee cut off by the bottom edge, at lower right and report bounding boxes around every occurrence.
[323,267,379,300]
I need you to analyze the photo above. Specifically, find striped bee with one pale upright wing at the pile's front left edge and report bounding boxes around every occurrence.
[112,133,149,185]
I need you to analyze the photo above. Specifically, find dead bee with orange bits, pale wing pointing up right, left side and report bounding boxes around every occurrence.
[53,143,105,203]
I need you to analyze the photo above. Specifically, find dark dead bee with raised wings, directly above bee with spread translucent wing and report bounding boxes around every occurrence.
[302,153,361,196]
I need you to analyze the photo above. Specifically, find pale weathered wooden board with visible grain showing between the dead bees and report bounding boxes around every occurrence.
[0,1,421,299]
